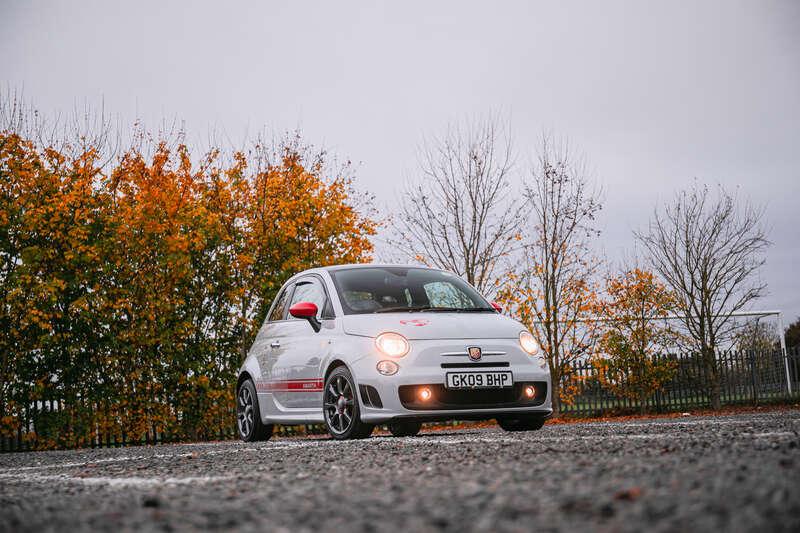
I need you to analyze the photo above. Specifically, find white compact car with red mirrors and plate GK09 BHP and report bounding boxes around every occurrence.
[236,265,552,441]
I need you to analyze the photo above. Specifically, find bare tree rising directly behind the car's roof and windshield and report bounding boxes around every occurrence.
[389,118,523,293]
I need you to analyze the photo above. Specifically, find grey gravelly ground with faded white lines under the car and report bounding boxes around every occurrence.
[0,410,800,531]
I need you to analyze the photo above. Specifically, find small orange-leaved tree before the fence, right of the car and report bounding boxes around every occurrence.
[593,267,677,413]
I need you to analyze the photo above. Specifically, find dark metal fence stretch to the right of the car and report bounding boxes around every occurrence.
[561,348,800,416]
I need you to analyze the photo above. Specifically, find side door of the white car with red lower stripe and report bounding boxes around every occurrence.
[270,275,330,410]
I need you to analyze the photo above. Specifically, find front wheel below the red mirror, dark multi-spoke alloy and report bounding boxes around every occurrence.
[322,366,375,440]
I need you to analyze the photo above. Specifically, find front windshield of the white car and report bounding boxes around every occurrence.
[331,267,494,315]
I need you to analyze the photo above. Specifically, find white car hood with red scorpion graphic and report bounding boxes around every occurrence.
[342,312,525,340]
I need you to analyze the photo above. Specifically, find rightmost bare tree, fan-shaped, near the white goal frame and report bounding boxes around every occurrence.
[636,184,770,409]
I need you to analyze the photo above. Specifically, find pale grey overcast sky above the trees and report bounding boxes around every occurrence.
[0,0,800,322]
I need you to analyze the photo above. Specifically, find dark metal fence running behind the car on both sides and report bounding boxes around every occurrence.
[0,348,800,452]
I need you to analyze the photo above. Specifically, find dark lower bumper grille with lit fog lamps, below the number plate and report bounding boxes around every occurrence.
[398,381,547,411]
